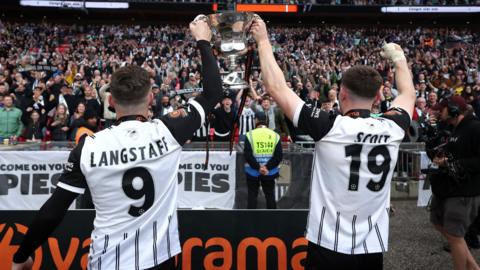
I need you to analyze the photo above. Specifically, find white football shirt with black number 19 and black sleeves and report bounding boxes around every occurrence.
[293,103,410,254]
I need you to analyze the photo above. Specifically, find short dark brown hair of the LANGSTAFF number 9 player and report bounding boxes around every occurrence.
[110,65,151,105]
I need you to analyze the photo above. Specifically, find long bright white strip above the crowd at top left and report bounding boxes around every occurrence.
[20,0,129,9]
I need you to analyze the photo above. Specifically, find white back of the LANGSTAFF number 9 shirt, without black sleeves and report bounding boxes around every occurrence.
[80,120,181,269]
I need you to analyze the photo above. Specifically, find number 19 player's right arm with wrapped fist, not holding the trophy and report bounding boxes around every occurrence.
[382,43,416,118]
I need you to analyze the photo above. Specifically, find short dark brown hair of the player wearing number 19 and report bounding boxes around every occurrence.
[342,65,383,98]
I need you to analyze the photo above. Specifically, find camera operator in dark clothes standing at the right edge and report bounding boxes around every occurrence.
[430,96,480,269]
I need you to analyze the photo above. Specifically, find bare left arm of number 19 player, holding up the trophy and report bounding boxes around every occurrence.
[251,19,302,121]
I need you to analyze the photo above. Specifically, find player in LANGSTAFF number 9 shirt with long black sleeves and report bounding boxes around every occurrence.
[13,16,223,270]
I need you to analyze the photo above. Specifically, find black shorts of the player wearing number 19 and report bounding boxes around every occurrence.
[305,242,383,270]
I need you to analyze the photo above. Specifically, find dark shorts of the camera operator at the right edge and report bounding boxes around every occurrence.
[430,195,480,237]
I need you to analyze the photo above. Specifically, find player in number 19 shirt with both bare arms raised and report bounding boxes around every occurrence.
[251,19,415,270]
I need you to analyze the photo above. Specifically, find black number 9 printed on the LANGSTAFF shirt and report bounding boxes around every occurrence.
[122,167,155,217]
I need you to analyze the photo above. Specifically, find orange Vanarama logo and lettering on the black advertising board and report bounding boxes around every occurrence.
[0,223,308,270]
